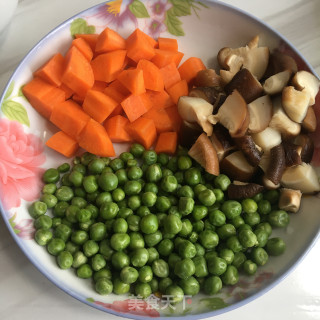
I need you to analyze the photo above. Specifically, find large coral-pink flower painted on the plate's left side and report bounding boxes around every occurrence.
[0,118,45,210]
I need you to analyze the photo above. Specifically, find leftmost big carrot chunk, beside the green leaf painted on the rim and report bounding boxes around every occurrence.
[22,78,66,119]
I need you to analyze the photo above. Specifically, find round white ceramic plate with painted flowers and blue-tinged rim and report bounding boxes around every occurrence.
[0,0,320,319]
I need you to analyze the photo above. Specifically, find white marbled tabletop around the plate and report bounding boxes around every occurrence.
[0,0,320,320]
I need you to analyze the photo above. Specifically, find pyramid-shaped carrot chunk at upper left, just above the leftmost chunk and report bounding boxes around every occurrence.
[33,53,64,87]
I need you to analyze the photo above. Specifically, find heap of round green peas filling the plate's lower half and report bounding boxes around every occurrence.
[29,144,289,303]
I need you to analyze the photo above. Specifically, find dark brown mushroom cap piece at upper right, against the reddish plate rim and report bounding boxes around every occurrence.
[264,51,298,78]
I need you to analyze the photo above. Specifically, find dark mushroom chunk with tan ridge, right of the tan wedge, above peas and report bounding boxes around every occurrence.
[220,151,256,182]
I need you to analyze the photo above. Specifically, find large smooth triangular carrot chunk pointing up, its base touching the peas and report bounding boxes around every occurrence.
[78,119,116,157]
